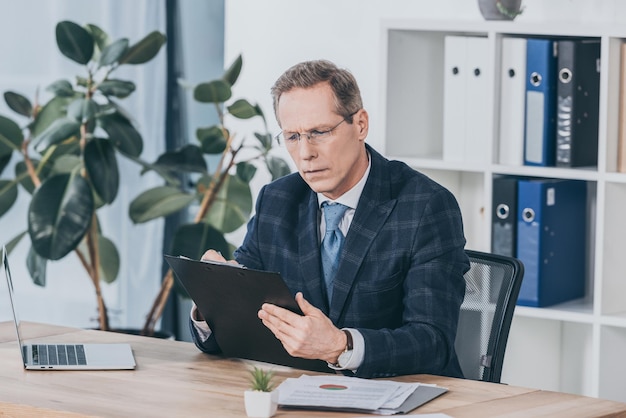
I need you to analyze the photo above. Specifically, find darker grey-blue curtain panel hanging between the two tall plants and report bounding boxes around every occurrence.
[161,0,224,340]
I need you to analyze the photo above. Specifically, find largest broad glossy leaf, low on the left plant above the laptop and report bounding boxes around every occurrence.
[28,174,94,260]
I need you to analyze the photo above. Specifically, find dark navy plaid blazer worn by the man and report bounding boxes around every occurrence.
[194,146,469,377]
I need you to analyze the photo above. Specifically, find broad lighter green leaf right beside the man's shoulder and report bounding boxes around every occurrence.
[204,175,252,233]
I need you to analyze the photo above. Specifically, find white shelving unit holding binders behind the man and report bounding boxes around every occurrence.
[380,20,626,402]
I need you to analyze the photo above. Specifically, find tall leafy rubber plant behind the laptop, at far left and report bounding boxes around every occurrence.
[0,21,166,330]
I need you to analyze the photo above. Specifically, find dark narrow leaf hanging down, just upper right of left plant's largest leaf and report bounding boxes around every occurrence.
[85,138,120,203]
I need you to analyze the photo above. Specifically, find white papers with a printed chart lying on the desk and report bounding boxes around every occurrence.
[278,375,419,411]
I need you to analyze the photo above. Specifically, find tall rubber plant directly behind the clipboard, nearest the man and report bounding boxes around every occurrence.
[129,56,290,335]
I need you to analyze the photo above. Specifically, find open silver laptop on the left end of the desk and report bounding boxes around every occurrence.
[0,246,136,370]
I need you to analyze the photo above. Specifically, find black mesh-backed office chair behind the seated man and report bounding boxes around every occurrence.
[454,250,524,383]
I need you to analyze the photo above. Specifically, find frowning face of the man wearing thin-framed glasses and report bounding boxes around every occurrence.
[277,83,369,199]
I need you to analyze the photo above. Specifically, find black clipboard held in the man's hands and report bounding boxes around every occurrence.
[165,255,332,373]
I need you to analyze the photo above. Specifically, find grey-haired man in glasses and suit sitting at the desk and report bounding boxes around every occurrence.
[192,61,469,377]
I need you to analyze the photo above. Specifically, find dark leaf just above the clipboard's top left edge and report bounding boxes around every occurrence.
[170,223,232,298]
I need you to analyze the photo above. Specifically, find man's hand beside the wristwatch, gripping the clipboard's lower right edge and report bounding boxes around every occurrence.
[259,292,347,364]
